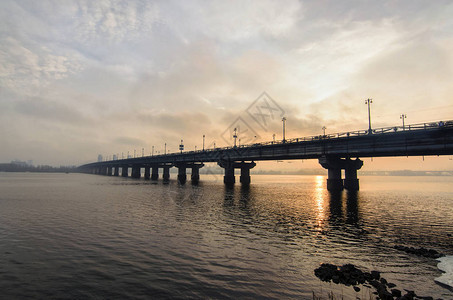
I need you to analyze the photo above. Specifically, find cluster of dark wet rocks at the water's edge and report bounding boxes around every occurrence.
[315,264,433,300]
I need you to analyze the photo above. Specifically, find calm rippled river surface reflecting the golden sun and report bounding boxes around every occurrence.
[0,173,453,299]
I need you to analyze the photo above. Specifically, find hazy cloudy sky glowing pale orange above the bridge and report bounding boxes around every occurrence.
[0,0,453,169]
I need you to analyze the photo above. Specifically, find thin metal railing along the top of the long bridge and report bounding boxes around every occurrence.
[107,121,453,160]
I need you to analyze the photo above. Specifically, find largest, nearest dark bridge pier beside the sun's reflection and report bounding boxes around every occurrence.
[319,156,363,191]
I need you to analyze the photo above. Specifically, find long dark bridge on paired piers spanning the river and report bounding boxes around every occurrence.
[78,121,453,191]
